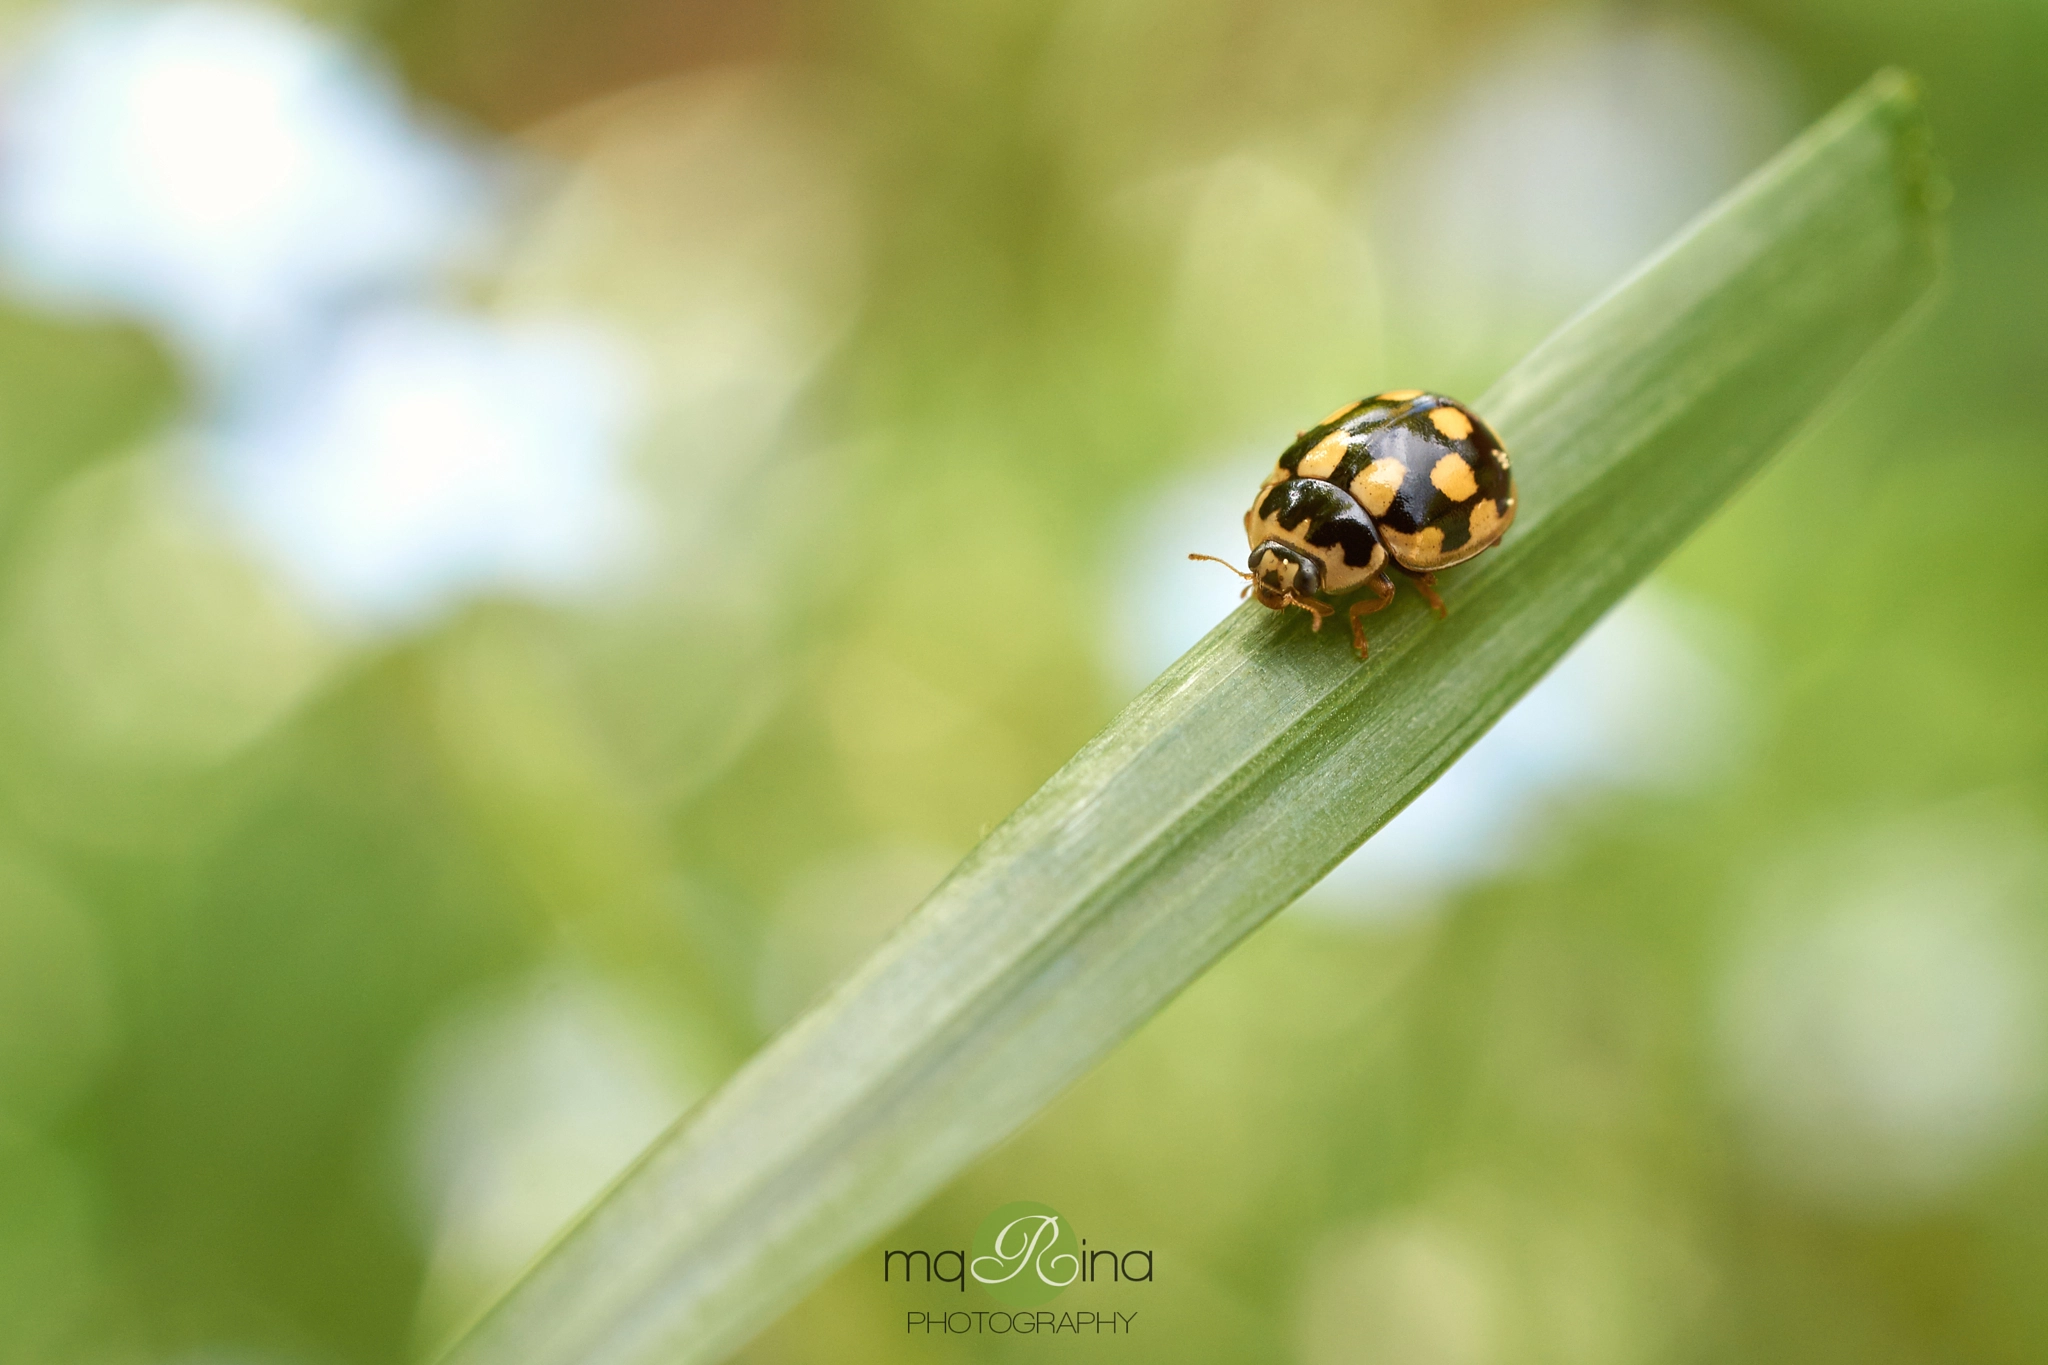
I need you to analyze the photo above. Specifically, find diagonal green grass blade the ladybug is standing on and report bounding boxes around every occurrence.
[432,74,1939,1365]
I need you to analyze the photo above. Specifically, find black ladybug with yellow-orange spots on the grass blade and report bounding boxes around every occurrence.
[1188,389,1516,659]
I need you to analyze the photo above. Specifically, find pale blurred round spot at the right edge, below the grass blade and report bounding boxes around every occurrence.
[1718,810,2048,1214]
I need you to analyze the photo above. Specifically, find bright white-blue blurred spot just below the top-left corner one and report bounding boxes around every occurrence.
[215,307,641,626]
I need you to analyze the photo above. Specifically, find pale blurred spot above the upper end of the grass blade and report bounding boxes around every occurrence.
[1364,12,1798,364]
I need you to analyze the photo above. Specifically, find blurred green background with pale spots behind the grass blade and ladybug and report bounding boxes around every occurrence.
[0,0,2048,1365]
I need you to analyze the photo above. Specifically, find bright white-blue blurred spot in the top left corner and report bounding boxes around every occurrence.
[0,2,494,372]
